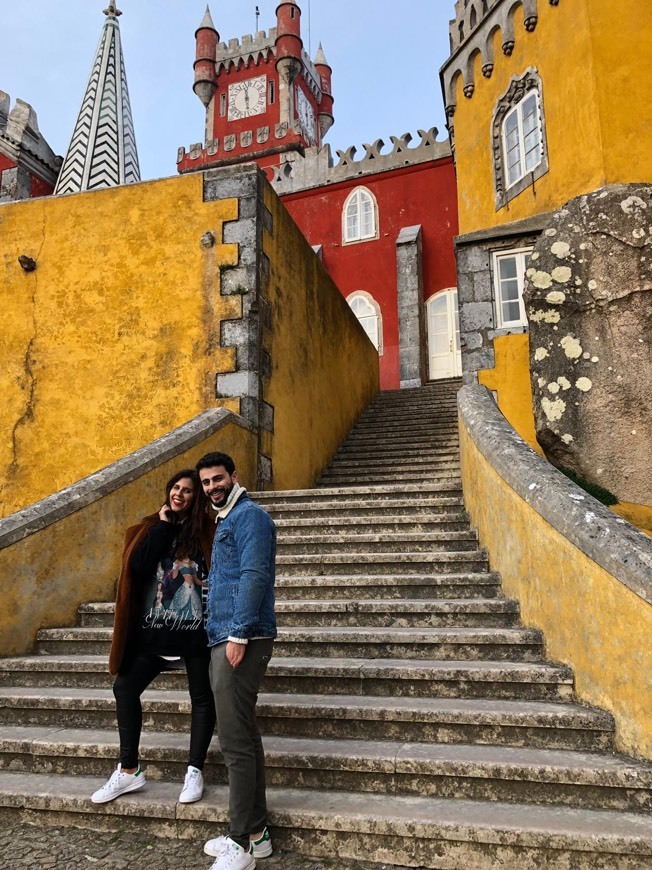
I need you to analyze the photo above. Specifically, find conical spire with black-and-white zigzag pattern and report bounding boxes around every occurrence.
[54,2,140,194]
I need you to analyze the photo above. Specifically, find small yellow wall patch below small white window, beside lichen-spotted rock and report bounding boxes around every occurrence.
[478,334,543,456]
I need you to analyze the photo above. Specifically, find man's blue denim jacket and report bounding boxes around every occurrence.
[206,493,276,646]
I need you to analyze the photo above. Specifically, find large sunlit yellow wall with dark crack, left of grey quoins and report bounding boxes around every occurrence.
[0,174,241,516]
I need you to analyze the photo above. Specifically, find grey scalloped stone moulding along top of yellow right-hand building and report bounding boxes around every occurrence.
[440,0,559,109]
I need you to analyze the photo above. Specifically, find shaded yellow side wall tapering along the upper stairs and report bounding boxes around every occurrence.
[263,185,379,490]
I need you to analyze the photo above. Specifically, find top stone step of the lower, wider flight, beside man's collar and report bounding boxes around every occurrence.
[251,482,462,509]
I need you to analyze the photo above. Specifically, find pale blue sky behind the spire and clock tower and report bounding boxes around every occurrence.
[0,0,454,179]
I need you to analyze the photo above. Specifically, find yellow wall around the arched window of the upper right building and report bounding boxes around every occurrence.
[454,0,652,234]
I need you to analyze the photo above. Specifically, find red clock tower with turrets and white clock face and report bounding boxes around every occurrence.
[178,0,333,172]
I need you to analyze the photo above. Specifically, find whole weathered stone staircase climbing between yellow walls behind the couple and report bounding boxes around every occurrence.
[0,381,652,870]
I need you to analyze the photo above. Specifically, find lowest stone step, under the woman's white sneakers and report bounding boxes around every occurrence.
[0,772,652,866]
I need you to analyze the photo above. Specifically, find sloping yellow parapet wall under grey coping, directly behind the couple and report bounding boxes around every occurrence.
[0,418,257,656]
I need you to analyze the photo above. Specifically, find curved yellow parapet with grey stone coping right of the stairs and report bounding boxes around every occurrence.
[458,386,652,758]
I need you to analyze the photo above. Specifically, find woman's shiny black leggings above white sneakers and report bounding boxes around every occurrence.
[113,649,215,770]
